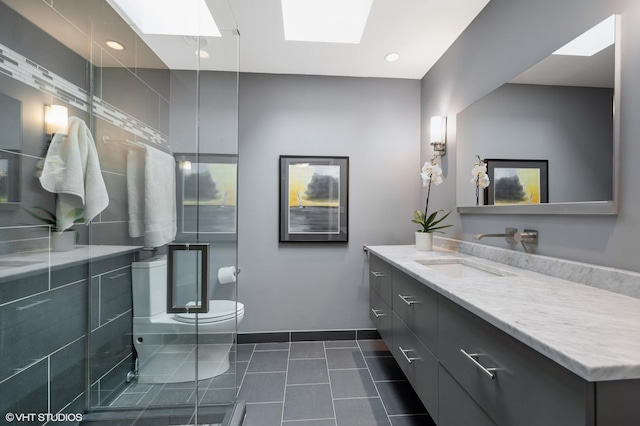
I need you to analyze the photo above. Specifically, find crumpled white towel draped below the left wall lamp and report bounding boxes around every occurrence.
[40,117,109,232]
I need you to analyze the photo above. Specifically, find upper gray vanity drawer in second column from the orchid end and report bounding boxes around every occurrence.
[393,269,438,354]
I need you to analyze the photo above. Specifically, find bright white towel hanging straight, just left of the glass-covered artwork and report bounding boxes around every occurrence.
[144,146,177,247]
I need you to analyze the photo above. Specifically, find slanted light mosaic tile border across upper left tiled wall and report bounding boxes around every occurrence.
[0,44,170,149]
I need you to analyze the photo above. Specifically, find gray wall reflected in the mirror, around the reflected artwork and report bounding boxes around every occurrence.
[456,84,613,206]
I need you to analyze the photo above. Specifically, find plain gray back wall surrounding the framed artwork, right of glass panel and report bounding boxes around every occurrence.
[238,74,420,332]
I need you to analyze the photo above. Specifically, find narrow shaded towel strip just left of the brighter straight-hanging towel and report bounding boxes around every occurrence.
[127,149,144,238]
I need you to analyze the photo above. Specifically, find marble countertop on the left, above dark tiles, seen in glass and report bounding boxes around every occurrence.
[0,245,142,280]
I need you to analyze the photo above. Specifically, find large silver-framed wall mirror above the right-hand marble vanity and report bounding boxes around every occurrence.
[456,15,620,214]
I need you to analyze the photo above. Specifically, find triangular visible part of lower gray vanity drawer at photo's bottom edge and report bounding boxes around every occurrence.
[438,366,496,426]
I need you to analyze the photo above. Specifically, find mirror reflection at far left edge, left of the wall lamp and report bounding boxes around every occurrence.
[0,93,22,204]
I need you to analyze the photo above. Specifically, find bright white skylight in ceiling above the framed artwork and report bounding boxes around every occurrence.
[282,0,373,44]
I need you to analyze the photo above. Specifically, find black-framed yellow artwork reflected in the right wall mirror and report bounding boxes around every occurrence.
[484,159,549,205]
